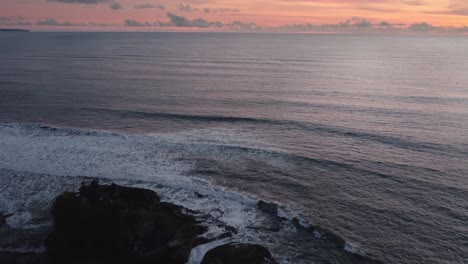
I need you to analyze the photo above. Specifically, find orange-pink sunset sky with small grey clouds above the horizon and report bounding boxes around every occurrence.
[0,0,468,30]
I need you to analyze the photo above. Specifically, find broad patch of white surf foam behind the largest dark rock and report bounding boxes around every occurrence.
[0,124,276,239]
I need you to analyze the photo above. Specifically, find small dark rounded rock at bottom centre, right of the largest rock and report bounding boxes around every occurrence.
[201,243,278,264]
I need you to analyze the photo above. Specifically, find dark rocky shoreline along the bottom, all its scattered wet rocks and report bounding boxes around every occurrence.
[0,180,381,264]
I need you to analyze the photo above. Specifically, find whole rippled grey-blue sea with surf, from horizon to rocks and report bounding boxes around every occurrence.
[0,33,468,263]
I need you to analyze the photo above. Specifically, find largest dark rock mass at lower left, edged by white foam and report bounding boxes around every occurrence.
[46,181,198,264]
